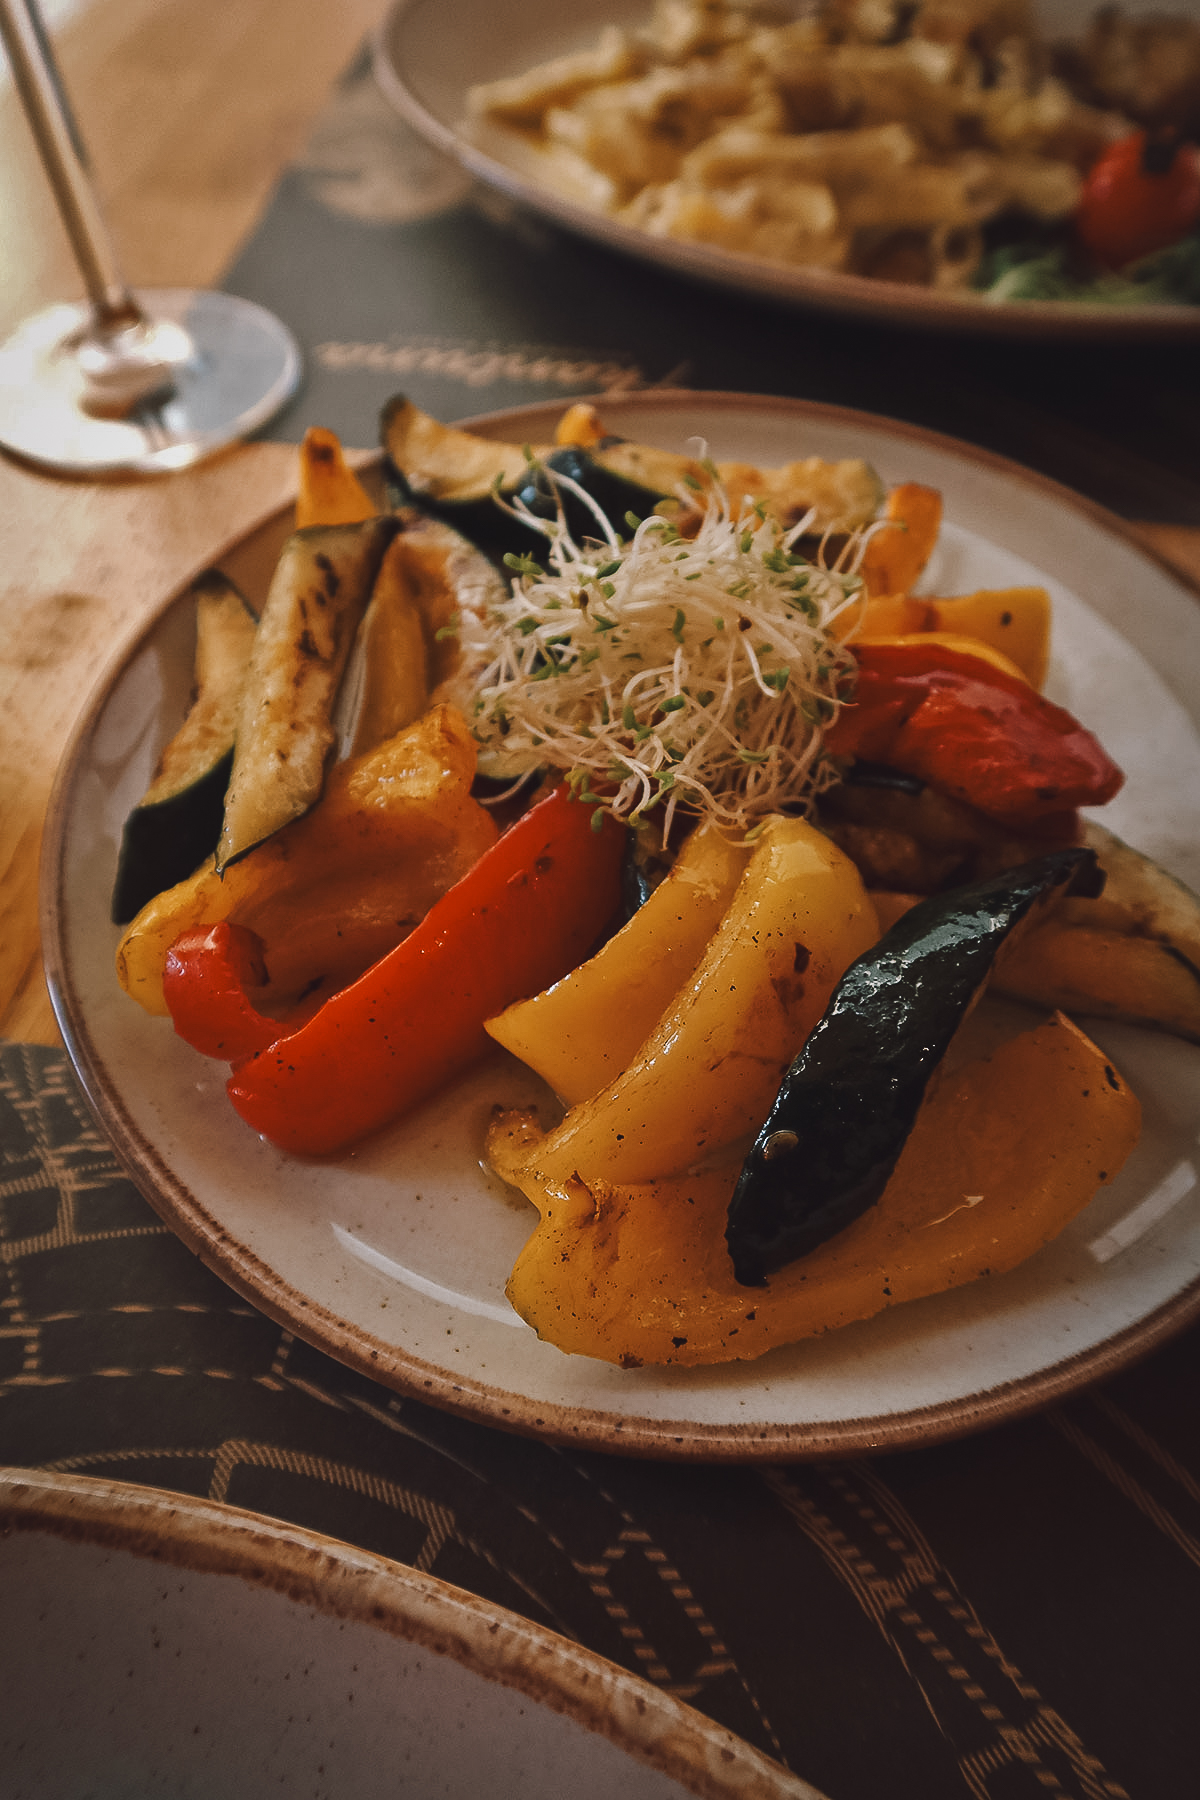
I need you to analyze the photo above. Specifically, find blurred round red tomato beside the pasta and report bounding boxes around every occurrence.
[1076,130,1200,268]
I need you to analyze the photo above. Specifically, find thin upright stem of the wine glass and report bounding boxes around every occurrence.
[0,0,142,329]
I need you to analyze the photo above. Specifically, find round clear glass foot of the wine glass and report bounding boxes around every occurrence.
[0,288,300,475]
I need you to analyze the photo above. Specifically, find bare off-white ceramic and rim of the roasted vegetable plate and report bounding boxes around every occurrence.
[43,394,1200,1460]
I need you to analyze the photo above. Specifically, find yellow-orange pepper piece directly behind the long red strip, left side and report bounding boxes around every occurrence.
[117,706,497,1013]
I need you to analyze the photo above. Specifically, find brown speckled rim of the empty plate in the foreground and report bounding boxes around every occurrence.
[0,1467,822,1800]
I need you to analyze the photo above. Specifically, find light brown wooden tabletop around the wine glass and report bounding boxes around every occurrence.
[0,0,1200,1044]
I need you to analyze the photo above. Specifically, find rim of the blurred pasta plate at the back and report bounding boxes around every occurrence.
[369,0,1200,344]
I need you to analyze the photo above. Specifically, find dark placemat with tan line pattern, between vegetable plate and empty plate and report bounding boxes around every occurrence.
[0,1044,1200,1800]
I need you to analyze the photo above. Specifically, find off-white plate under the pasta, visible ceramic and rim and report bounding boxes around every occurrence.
[374,0,1200,338]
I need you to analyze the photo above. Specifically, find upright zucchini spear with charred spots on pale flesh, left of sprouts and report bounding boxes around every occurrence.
[216,518,398,869]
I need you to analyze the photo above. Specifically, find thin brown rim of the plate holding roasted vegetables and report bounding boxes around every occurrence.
[40,389,1200,1463]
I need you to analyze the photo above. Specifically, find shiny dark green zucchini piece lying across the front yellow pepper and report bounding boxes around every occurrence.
[725,848,1103,1287]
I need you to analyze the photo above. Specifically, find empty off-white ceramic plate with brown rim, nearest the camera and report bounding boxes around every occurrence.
[0,1471,820,1800]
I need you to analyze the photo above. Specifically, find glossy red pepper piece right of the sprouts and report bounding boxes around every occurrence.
[826,643,1124,826]
